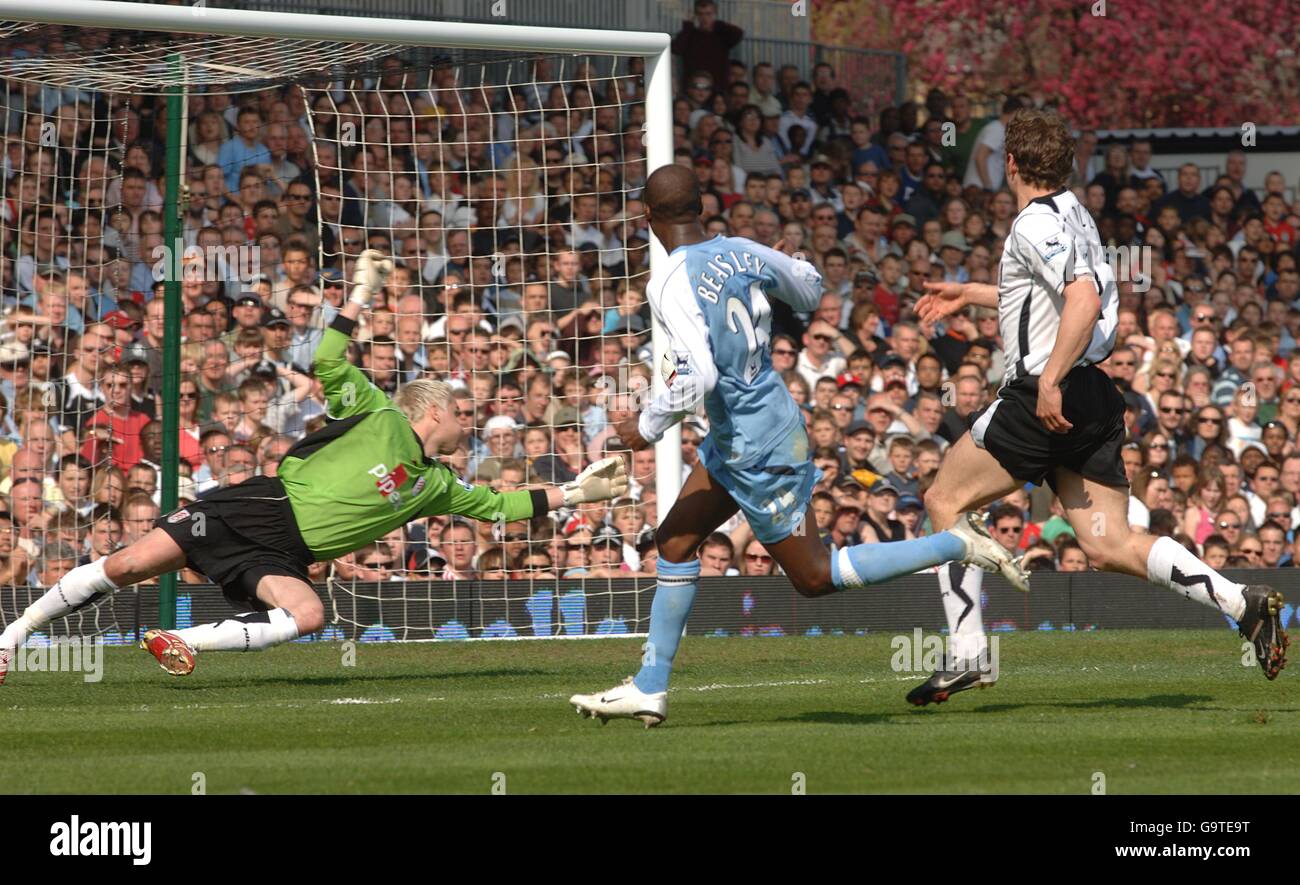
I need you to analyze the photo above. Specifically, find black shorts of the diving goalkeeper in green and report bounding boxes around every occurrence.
[153,477,316,611]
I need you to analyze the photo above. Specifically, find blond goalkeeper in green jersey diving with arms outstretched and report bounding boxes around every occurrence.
[0,250,628,684]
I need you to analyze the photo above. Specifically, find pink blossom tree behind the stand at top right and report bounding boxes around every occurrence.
[813,0,1300,129]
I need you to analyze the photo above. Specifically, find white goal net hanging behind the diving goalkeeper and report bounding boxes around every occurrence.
[0,3,680,641]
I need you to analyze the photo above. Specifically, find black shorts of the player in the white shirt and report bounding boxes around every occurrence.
[967,365,1128,491]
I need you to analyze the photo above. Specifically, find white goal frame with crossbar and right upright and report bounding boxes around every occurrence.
[0,0,681,519]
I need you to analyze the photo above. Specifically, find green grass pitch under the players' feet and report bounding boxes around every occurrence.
[0,630,1300,794]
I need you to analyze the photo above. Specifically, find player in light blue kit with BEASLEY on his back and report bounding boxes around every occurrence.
[571,165,1028,728]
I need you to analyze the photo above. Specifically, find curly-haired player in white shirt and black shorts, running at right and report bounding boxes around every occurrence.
[917,110,1287,697]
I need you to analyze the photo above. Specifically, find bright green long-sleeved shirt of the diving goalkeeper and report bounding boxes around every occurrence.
[278,316,545,561]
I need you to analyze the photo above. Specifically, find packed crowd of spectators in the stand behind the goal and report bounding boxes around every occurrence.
[0,10,1300,586]
